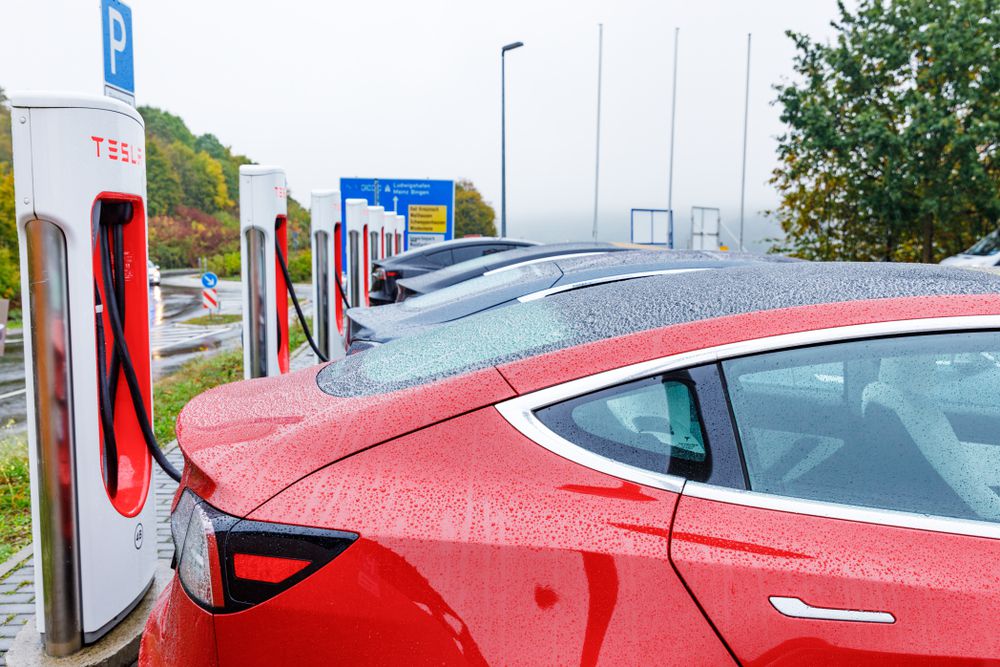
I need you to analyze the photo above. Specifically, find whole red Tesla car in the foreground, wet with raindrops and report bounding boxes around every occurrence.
[140,263,1000,666]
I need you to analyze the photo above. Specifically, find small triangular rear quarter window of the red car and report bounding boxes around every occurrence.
[535,377,710,481]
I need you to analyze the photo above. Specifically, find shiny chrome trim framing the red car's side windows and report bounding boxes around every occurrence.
[496,315,1000,539]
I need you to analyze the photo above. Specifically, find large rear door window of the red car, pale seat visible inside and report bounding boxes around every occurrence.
[722,333,1000,521]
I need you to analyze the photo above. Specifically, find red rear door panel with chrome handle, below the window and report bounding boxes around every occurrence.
[670,496,1000,667]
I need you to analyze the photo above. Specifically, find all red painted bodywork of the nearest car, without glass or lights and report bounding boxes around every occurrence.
[140,295,1000,665]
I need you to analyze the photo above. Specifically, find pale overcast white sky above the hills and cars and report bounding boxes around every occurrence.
[0,0,848,250]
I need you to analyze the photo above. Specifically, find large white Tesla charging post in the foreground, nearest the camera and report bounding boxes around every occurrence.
[11,94,156,655]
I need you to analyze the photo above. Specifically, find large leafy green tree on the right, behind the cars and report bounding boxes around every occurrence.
[771,0,1000,262]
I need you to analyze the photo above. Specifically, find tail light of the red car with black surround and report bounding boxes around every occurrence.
[170,489,358,613]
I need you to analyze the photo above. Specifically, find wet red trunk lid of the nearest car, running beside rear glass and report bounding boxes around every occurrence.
[177,367,514,516]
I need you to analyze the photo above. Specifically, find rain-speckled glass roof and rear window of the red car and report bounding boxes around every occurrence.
[317,262,1000,396]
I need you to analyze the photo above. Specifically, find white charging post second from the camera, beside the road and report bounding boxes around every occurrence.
[240,164,289,379]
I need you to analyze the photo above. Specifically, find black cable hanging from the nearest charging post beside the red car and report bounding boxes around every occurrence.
[94,206,181,488]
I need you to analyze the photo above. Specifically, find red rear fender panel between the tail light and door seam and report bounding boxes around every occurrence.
[205,408,732,665]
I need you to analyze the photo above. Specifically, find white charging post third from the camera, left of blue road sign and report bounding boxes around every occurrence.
[310,190,344,359]
